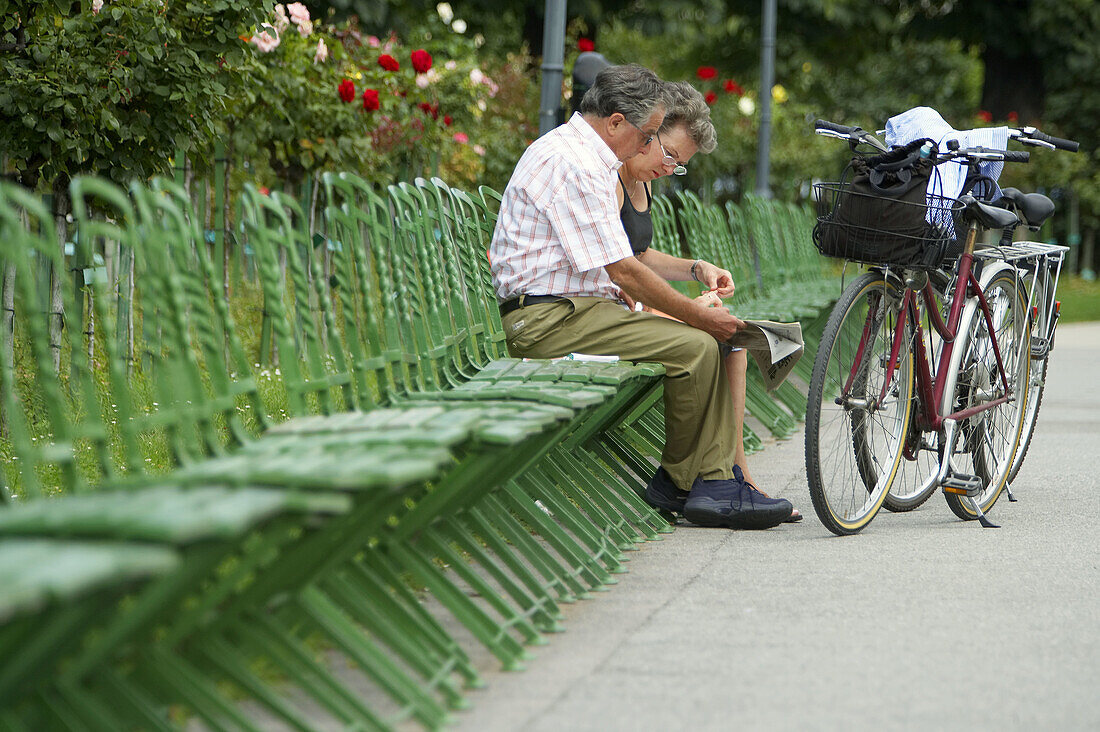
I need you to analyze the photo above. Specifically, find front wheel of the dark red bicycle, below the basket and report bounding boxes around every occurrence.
[805,272,913,536]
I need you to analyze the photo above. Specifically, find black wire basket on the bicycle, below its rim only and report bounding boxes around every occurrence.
[813,181,963,267]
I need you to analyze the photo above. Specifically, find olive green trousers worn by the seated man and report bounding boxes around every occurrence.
[504,297,735,491]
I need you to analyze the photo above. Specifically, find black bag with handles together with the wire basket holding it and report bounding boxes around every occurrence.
[814,140,955,266]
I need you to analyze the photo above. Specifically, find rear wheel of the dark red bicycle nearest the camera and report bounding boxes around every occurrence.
[944,272,1031,521]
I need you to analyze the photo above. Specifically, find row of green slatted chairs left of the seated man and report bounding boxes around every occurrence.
[0,169,668,729]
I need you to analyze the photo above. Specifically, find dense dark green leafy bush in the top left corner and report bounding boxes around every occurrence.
[0,0,264,193]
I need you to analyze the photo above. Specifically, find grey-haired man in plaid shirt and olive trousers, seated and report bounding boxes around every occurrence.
[490,65,791,528]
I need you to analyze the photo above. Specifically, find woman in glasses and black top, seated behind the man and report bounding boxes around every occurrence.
[617,81,802,522]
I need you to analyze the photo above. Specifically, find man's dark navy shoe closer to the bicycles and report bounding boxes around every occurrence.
[683,478,793,528]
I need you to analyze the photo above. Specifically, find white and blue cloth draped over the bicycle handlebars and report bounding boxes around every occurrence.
[887,107,1009,200]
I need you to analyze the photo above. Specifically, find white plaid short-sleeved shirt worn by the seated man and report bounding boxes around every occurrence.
[490,113,634,301]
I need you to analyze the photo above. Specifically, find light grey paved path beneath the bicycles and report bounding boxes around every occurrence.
[459,324,1100,732]
